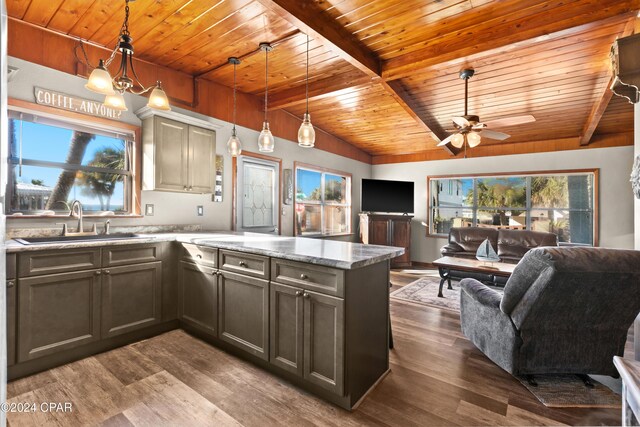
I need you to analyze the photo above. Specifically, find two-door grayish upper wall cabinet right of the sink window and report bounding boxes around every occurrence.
[142,116,216,193]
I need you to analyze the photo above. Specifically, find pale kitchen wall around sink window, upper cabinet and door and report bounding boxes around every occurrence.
[7,58,371,239]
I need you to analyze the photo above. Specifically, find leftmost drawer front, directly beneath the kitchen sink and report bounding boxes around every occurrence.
[18,248,100,277]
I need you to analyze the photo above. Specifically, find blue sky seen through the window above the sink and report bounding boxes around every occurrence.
[15,120,124,209]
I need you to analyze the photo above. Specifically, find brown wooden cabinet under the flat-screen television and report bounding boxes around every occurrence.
[360,213,413,268]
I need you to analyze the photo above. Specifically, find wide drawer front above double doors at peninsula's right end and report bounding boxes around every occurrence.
[271,259,344,297]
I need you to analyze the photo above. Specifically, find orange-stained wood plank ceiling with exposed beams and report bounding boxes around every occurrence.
[7,0,640,160]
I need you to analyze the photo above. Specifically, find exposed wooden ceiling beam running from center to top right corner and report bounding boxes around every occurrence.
[382,0,640,81]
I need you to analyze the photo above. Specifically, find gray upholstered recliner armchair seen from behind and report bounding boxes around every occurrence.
[460,247,640,375]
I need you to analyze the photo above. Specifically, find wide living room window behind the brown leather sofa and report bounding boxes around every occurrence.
[427,169,598,245]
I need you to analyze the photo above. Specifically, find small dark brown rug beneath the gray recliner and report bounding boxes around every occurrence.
[516,375,622,408]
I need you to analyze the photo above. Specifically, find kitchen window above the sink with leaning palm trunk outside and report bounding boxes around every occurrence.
[7,111,133,215]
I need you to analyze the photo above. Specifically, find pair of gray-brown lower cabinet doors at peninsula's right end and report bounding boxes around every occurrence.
[270,282,345,396]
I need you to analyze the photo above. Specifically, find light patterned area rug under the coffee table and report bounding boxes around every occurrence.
[390,277,460,313]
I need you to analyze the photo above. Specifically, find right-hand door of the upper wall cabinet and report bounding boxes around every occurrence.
[189,126,216,193]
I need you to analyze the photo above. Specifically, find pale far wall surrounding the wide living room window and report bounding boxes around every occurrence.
[373,148,640,262]
